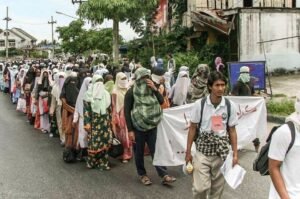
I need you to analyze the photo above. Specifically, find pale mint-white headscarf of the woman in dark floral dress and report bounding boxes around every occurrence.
[84,75,111,115]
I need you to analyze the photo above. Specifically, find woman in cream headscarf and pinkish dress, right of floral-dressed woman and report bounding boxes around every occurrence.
[112,72,132,163]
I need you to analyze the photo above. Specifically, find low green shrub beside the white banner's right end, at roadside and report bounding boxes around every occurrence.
[267,98,295,116]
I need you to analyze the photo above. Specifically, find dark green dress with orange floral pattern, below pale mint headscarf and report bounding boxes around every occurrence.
[84,102,112,169]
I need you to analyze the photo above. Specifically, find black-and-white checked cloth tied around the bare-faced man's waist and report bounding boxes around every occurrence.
[196,132,229,160]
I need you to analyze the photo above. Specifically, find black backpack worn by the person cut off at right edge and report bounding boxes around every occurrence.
[253,122,295,176]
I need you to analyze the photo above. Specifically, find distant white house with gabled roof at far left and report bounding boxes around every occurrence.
[0,28,37,50]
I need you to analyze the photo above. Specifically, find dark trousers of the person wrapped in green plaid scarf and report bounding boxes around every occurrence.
[133,128,167,177]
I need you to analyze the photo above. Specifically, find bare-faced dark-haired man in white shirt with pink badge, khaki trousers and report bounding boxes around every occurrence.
[186,72,238,199]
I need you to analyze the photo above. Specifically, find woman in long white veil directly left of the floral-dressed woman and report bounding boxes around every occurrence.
[73,77,92,158]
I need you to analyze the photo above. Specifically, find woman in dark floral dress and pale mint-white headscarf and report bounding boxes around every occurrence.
[83,75,112,170]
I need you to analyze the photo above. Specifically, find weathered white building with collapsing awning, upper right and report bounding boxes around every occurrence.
[176,0,300,70]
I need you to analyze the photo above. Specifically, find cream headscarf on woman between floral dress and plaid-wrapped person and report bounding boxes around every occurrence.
[112,72,128,113]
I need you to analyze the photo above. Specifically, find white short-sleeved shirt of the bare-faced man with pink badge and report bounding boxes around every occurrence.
[191,95,238,136]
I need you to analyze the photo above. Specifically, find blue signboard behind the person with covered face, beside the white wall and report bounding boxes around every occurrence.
[227,61,266,90]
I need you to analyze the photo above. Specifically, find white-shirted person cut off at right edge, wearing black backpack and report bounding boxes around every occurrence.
[268,95,300,199]
